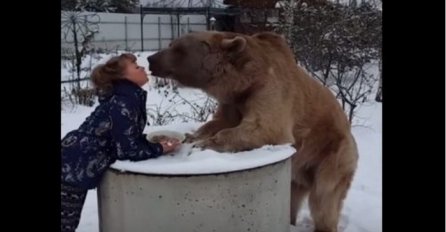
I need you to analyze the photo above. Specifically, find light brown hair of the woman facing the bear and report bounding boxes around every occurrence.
[91,53,136,95]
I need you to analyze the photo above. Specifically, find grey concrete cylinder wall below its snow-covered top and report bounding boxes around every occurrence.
[98,156,291,232]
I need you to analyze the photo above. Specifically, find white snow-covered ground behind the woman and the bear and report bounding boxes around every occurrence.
[61,53,382,232]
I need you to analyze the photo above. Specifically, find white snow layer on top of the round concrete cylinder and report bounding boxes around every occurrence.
[111,123,296,175]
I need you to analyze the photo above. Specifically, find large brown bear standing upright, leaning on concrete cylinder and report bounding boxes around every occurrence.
[147,31,358,232]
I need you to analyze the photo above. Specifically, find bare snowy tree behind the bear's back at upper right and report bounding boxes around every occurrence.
[277,0,382,122]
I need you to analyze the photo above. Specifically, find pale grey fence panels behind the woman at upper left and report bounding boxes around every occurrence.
[61,12,207,52]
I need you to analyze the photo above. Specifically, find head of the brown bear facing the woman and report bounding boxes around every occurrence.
[147,31,258,94]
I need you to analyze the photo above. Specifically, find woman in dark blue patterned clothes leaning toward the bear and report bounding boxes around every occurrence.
[61,53,180,231]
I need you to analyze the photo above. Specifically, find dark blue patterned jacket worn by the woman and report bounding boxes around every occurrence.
[61,80,163,189]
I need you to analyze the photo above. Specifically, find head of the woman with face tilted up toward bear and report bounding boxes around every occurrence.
[91,53,149,94]
